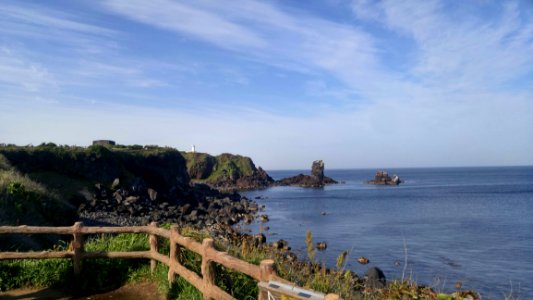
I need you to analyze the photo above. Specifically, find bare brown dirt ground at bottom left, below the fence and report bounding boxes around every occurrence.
[0,282,166,300]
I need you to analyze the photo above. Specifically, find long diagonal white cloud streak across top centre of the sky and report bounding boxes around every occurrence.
[105,0,389,99]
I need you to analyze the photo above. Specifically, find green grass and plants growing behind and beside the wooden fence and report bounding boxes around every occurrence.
[0,225,476,300]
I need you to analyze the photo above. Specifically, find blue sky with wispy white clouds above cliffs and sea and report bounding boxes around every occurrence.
[0,0,533,170]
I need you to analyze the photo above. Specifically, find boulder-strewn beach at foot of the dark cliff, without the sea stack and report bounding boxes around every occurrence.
[78,180,260,232]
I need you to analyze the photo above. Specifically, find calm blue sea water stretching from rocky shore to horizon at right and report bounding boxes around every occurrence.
[244,167,533,299]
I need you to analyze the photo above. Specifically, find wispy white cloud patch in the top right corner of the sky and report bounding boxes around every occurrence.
[353,0,533,93]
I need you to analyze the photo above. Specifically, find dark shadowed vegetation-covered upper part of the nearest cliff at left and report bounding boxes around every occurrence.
[0,143,189,197]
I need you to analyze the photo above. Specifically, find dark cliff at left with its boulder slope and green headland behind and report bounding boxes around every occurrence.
[0,143,260,248]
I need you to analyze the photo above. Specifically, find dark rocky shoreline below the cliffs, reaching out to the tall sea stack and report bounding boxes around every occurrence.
[77,160,337,241]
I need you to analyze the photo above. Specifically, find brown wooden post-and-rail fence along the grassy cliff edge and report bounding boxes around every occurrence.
[0,222,340,300]
